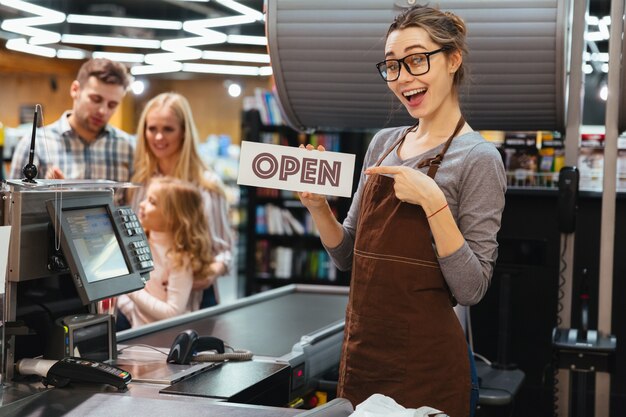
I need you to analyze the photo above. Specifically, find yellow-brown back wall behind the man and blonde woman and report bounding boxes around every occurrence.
[0,47,271,143]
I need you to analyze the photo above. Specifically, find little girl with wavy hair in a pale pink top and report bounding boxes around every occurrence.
[118,177,213,327]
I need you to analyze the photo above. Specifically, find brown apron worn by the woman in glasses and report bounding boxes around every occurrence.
[338,117,471,417]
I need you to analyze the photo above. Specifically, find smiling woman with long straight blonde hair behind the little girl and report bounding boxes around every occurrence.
[129,92,233,307]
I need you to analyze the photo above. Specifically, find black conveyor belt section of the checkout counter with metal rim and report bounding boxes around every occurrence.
[117,284,348,405]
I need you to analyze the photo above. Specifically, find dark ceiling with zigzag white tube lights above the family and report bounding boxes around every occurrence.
[0,0,271,76]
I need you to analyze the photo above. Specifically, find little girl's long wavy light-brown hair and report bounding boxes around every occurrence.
[148,177,213,279]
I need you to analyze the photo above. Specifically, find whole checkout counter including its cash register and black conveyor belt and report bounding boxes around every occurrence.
[0,180,353,417]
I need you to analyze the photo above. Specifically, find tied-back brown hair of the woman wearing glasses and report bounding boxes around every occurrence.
[387,4,468,88]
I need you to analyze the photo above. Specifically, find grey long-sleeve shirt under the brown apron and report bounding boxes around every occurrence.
[326,127,506,305]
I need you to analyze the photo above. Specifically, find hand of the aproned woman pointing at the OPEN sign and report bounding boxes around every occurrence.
[365,166,445,214]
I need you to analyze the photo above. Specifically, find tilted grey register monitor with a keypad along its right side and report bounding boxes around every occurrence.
[46,197,152,304]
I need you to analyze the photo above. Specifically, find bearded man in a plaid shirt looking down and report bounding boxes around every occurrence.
[9,58,133,181]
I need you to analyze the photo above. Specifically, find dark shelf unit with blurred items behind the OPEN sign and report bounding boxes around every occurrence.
[242,110,367,294]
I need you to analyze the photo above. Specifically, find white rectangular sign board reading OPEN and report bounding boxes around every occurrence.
[237,141,355,197]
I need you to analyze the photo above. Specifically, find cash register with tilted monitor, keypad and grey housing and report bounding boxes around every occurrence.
[0,180,153,381]
